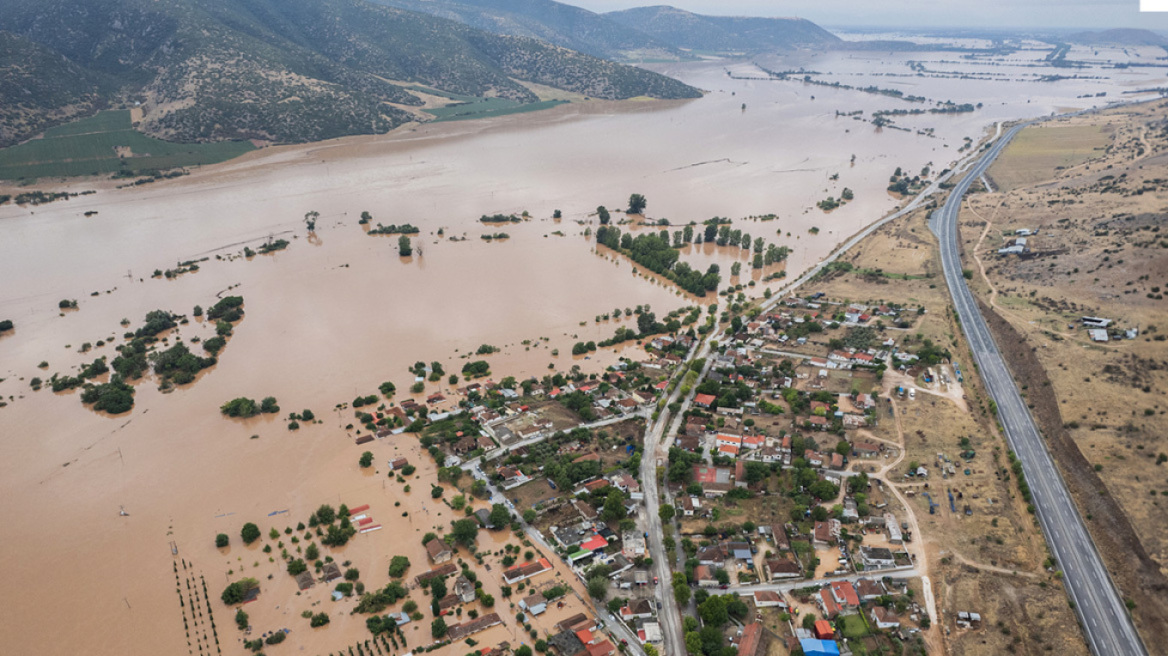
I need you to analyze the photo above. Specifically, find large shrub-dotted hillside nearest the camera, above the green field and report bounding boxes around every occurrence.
[0,0,698,145]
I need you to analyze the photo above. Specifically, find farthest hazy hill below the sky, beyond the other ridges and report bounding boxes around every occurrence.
[604,6,841,51]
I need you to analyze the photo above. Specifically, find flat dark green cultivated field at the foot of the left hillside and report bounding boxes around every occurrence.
[0,110,255,180]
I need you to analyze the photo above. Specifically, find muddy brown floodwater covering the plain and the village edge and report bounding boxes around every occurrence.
[0,50,1164,655]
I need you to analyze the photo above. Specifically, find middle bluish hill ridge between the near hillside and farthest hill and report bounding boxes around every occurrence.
[374,0,679,60]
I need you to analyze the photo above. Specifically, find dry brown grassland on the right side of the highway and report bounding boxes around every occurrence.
[960,102,1168,644]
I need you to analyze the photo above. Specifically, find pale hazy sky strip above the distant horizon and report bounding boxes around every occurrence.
[561,0,1168,30]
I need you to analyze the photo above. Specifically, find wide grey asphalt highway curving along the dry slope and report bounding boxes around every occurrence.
[930,125,1147,656]
